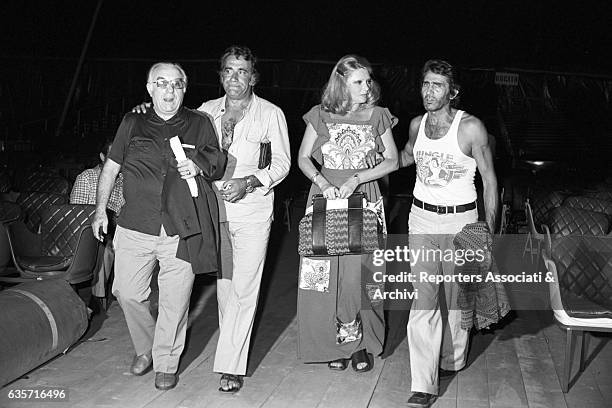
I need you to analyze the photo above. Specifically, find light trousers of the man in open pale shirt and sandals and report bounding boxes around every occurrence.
[213,220,272,375]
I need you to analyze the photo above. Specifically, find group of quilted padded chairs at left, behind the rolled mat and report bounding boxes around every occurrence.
[3,171,98,285]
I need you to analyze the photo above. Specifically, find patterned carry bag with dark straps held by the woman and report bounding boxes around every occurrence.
[298,192,384,257]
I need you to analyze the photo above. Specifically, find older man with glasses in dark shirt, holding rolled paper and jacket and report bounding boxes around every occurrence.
[92,62,227,390]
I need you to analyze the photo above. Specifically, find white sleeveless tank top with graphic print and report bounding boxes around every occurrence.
[413,110,476,205]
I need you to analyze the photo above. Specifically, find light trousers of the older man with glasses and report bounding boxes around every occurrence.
[113,226,194,373]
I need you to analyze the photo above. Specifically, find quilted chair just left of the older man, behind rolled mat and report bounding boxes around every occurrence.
[7,204,98,285]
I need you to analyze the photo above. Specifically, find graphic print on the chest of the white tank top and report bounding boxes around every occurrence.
[415,150,468,187]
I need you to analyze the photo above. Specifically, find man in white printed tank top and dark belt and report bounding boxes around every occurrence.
[400,60,498,407]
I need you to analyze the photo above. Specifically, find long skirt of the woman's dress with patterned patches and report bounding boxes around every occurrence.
[297,168,385,362]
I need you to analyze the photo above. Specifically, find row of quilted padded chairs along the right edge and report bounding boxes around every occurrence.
[524,191,612,392]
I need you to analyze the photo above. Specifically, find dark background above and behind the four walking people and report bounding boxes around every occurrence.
[0,0,612,191]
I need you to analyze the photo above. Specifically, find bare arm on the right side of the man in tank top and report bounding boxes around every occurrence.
[464,118,499,233]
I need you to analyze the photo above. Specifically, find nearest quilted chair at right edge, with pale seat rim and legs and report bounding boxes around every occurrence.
[543,235,612,392]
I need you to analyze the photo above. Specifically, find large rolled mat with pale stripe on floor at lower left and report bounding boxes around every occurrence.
[0,279,87,386]
